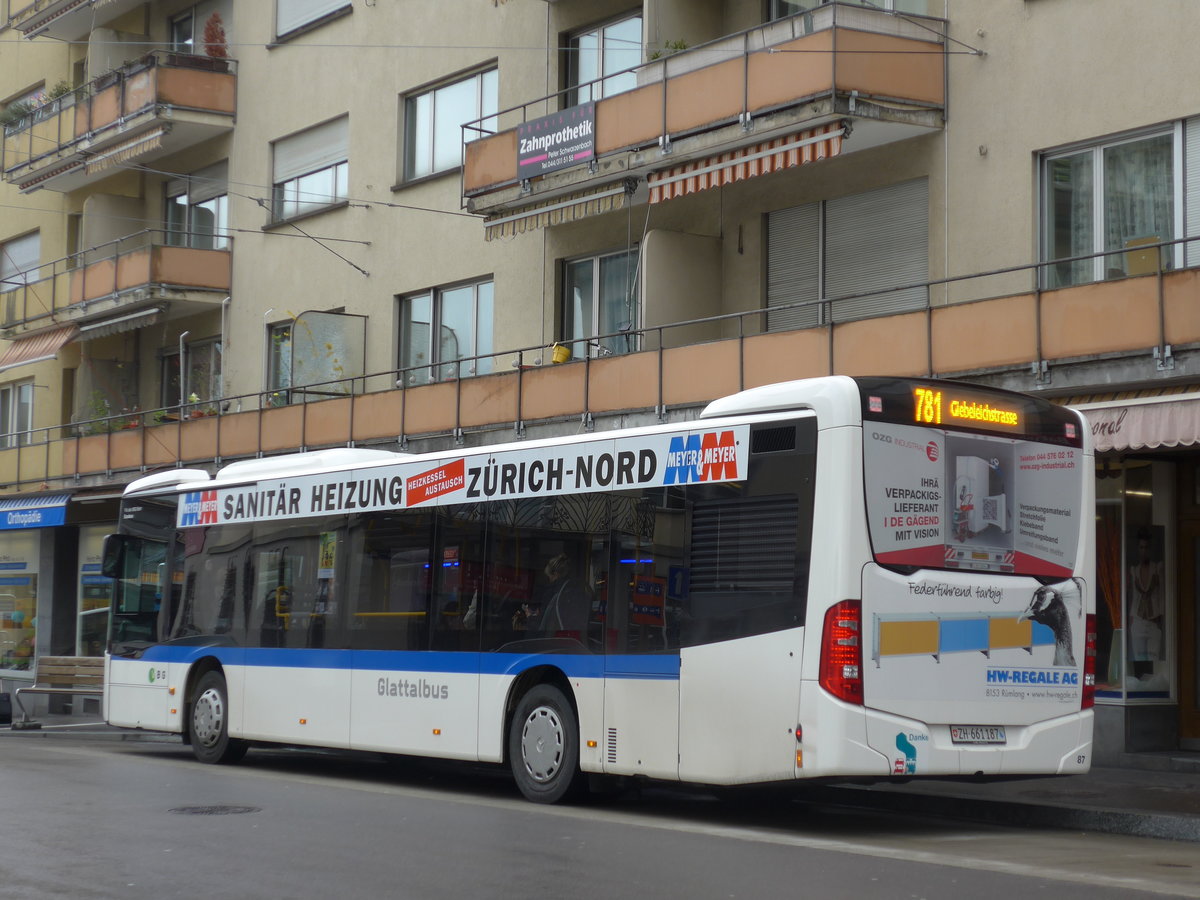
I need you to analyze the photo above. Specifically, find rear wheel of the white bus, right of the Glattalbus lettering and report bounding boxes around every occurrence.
[509,684,583,803]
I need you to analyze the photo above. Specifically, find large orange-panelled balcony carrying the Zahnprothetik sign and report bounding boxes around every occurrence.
[463,4,947,217]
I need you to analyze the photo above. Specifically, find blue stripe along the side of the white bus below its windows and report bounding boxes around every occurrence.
[140,644,679,680]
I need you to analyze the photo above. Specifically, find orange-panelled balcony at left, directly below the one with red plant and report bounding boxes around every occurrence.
[0,230,233,341]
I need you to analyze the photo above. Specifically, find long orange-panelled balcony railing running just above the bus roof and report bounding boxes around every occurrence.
[0,239,1200,490]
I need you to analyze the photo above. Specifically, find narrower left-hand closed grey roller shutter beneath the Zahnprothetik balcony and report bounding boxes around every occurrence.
[767,203,821,331]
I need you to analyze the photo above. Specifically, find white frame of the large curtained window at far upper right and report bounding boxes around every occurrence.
[1038,120,1187,288]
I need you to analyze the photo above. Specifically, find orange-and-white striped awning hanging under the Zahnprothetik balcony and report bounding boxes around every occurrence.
[647,121,850,203]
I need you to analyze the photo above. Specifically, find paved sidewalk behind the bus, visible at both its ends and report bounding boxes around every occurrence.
[0,715,1200,842]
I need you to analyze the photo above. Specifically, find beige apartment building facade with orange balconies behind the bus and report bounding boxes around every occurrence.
[0,0,1200,757]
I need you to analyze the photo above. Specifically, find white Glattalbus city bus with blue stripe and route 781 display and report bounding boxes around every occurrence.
[104,377,1094,802]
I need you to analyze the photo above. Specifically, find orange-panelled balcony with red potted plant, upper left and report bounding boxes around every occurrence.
[4,50,238,192]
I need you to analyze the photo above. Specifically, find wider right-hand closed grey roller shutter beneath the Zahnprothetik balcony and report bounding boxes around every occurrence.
[826,178,929,322]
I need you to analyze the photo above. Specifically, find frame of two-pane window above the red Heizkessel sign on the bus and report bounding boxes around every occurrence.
[396,275,496,386]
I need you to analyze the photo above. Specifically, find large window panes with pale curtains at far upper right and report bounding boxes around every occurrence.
[1042,128,1182,287]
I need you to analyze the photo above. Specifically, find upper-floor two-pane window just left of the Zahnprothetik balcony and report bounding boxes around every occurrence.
[404,68,499,181]
